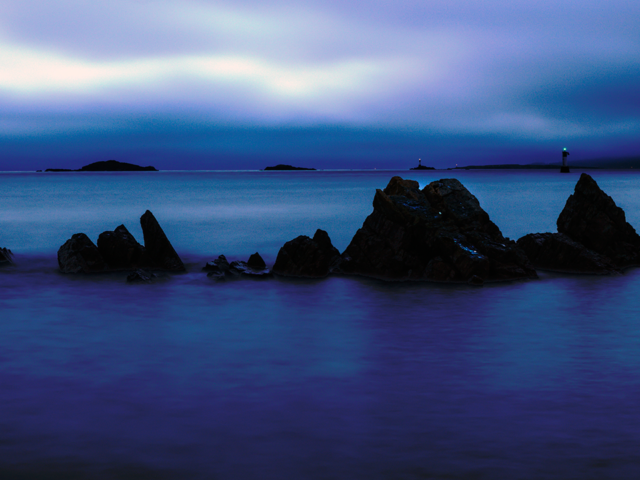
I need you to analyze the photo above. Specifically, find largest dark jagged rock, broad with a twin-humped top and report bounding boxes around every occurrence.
[339,177,537,283]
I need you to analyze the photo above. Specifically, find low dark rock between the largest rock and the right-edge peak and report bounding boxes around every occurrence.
[517,233,617,274]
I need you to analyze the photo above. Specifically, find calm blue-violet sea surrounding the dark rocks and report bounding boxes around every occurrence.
[0,171,640,479]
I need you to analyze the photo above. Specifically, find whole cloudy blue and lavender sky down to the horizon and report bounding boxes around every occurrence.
[0,0,640,170]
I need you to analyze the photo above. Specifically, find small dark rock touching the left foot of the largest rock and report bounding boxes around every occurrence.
[273,229,340,278]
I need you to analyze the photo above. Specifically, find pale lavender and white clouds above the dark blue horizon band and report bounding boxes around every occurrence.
[0,0,640,167]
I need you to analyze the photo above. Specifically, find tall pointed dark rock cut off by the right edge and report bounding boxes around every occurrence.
[557,173,640,268]
